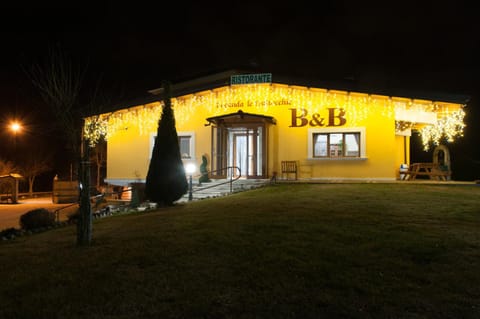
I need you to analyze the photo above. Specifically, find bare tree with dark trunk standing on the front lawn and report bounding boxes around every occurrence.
[27,47,109,246]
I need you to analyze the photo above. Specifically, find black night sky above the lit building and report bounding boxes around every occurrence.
[0,1,480,180]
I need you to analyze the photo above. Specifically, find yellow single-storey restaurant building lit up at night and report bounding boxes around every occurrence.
[87,72,465,185]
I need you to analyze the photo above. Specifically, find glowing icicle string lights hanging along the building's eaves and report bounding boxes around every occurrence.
[84,83,465,151]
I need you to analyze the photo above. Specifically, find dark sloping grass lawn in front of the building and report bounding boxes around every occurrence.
[0,184,480,319]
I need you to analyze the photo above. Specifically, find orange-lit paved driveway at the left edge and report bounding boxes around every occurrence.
[0,197,77,231]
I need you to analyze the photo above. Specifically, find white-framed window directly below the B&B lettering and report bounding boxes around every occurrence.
[308,128,365,159]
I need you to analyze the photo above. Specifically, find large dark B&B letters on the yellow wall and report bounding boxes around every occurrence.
[290,108,347,127]
